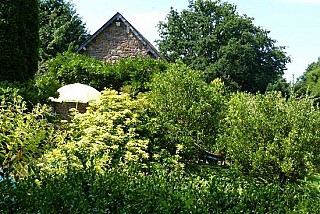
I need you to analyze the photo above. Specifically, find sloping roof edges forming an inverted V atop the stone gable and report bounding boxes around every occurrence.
[77,12,163,59]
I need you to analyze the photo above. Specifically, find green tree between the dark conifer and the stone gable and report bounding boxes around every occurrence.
[39,0,89,60]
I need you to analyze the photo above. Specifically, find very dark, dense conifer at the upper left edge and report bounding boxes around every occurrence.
[0,0,39,82]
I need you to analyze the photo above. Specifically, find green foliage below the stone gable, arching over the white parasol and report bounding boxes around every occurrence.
[0,52,167,105]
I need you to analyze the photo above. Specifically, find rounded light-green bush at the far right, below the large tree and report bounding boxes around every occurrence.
[218,92,320,183]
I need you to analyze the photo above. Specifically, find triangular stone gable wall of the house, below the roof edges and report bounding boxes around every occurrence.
[79,20,153,63]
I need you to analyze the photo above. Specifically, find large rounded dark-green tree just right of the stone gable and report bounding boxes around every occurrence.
[158,0,290,92]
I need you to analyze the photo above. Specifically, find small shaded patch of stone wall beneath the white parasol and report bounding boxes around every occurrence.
[52,102,89,120]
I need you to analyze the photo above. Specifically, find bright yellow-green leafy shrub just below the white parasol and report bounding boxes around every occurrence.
[40,89,149,172]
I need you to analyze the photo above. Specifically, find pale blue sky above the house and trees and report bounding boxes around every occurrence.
[72,0,320,81]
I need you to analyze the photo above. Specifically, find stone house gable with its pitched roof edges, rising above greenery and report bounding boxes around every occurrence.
[77,13,162,62]
